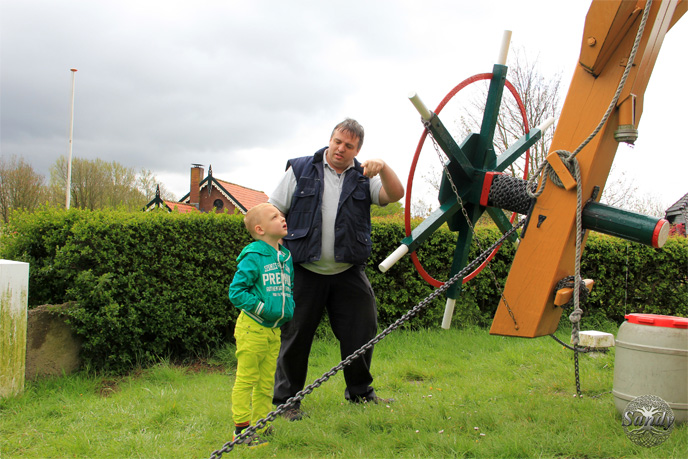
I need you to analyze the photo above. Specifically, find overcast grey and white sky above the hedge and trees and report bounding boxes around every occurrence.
[0,0,688,206]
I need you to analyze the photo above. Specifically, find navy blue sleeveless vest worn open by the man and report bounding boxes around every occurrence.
[284,147,372,265]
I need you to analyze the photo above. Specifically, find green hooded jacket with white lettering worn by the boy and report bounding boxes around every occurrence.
[229,241,294,328]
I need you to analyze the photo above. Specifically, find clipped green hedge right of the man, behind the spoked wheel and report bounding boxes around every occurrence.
[368,221,688,328]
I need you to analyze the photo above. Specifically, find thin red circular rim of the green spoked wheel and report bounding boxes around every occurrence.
[404,73,530,287]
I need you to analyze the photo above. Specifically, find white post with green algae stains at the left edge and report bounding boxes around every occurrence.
[0,260,29,398]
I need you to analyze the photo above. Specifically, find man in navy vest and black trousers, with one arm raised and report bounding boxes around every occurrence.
[269,119,404,420]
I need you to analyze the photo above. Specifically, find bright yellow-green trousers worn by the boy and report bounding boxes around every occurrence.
[232,311,281,425]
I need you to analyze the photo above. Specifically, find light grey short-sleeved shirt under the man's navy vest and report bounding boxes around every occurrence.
[268,154,382,275]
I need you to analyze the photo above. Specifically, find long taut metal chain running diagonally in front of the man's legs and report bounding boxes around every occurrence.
[210,219,525,459]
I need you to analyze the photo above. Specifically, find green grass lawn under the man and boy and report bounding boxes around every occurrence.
[0,329,688,459]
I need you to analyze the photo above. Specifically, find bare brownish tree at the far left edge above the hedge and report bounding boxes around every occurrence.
[0,156,47,223]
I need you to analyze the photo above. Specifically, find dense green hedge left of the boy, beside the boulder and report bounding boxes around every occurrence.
[2,209,249,371]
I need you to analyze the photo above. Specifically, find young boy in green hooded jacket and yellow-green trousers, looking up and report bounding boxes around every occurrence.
[229,203,294,446]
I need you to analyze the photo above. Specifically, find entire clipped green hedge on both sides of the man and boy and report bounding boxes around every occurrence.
[0,209,688,371]
